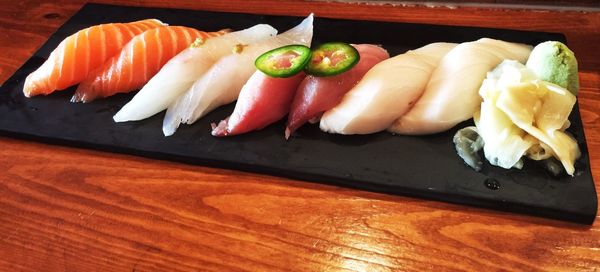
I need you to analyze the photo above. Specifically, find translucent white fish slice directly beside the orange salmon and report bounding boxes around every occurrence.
[113,24,277,122]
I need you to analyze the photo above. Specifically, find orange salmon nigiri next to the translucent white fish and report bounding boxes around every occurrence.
[71,26,228,102]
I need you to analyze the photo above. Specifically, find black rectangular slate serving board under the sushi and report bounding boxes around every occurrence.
[0,4,597,224]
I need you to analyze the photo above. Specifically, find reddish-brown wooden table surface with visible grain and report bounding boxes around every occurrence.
[0,0,600,271]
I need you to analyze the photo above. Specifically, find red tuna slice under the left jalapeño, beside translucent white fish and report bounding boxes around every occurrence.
[212,71,305,136]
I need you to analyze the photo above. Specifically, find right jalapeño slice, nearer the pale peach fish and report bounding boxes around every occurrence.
[306,42,360,76]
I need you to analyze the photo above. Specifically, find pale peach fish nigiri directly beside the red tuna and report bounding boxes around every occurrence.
[320,43,456,134]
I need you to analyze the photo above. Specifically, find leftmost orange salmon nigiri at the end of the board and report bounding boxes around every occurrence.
[23,19,165,97]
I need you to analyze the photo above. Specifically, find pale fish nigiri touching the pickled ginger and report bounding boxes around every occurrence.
[388,38,531,135]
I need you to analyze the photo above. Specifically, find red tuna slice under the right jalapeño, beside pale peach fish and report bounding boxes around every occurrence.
[285,44,390,139]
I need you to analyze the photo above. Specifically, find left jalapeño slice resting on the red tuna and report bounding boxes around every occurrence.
[254,44,310,77]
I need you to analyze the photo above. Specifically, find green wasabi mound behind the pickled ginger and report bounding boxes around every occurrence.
[527,41,579,95]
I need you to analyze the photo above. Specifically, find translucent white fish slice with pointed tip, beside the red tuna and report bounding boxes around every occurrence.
[163,14,313,136]
